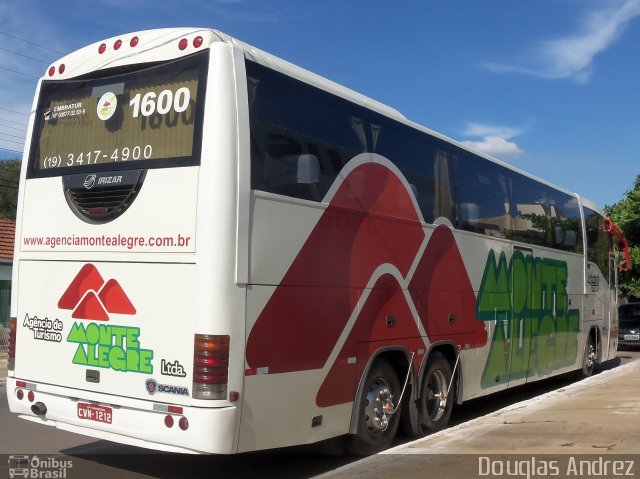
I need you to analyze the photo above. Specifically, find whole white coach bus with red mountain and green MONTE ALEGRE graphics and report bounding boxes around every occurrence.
[7,28,628,454]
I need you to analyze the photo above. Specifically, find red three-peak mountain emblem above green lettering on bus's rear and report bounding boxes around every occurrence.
[58,263,136,321]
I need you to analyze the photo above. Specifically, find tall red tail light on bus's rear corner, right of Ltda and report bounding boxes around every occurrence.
[193,334,230,399]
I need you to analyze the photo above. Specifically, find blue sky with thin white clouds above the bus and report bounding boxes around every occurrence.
[0,0,640,206]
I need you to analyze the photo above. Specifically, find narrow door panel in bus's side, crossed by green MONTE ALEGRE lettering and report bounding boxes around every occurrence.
[507,246,536,387]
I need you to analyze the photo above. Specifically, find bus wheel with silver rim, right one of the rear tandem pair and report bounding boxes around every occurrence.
[418,351,454,434]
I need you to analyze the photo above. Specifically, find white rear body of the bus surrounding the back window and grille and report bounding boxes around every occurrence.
[7,37,248,454]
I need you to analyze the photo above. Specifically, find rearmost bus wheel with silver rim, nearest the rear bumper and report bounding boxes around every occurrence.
[347,359,400,454]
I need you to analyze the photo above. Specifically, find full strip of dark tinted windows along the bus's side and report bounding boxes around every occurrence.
[246,60,582,252]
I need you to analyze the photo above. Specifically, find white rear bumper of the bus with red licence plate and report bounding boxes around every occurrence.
[7,377,239,454]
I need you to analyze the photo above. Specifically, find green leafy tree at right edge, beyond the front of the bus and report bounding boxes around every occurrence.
[605,175,640,301]
